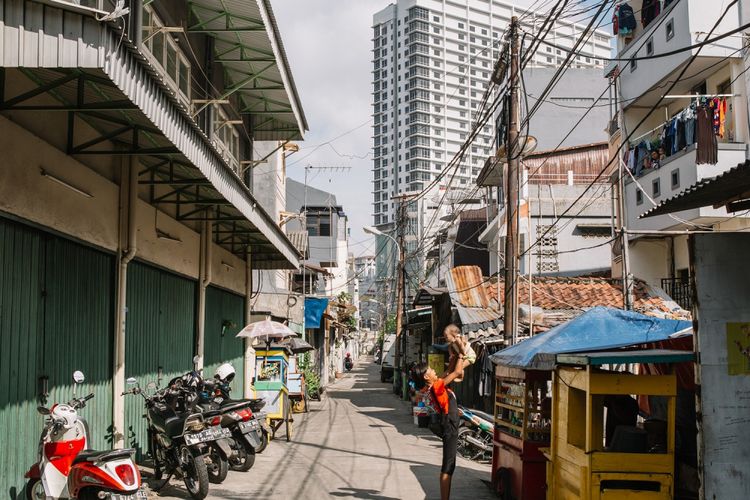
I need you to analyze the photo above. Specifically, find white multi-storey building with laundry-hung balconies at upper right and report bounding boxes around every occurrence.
[608,0,750,309]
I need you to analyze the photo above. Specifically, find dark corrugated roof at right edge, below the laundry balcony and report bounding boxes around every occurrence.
[639,161,750,218]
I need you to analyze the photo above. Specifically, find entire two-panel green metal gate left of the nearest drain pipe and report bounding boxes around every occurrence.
[0,219,114,498]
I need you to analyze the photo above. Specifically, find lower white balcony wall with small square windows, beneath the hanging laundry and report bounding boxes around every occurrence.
[625,143,746,231]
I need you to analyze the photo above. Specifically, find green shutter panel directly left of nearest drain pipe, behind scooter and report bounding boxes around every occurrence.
[44,237,115,449]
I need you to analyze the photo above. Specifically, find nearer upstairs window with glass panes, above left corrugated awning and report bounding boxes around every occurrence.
[143,6,190,106]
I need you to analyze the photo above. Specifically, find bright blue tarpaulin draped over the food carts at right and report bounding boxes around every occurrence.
[490,307,692,370]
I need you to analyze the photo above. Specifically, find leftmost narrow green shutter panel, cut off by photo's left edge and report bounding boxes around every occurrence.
[0,219,44,498]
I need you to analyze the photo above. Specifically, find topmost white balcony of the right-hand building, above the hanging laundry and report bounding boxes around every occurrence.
[616,0,742,108]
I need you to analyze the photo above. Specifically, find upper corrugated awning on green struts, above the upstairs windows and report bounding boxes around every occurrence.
[187,0,308,141]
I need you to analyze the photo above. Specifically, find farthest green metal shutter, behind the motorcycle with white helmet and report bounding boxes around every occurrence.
[203,286,245,398]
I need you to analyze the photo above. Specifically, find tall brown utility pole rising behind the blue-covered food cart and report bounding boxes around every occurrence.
[503,16,521,344]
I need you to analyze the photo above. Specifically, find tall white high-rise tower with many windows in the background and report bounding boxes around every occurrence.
[372,0,611,286]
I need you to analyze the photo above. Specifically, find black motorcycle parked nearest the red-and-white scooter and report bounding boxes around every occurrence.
[123,377,231,500]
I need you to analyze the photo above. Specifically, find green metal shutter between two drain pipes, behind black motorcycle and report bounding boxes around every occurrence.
[125,262,195,457]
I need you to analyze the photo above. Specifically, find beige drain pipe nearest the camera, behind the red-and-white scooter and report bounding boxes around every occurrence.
[112,156,138,448]
